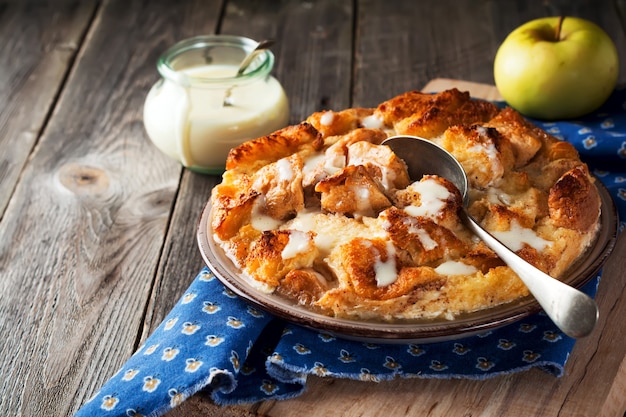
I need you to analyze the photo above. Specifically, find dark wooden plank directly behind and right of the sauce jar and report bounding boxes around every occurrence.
[222,0,353,123]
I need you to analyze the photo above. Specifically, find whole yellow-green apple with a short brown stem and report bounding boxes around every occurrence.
[494,17,619,120]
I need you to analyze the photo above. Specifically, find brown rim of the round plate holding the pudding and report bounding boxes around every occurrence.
[197,181,618,343]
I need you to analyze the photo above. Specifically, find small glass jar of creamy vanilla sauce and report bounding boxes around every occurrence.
[143,35,289,174]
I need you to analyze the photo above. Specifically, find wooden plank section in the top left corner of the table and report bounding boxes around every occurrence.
[0,2,95,218]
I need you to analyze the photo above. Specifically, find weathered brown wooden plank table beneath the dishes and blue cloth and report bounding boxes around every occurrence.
[0,0,626,417]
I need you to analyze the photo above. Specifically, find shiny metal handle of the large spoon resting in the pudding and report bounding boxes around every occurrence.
[465,212,598,338]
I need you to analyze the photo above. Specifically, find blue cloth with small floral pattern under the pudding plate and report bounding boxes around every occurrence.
[75,89,626,417]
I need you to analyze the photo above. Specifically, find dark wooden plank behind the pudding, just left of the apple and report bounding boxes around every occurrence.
[354,0,502,106]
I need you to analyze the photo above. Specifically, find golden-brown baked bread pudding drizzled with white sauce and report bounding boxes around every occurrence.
[210,89,600,322]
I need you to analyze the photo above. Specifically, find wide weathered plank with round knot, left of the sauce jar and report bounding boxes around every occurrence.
[0,0,228,415]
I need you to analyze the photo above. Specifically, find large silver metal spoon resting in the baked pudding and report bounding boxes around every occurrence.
[383,136,598,338]
